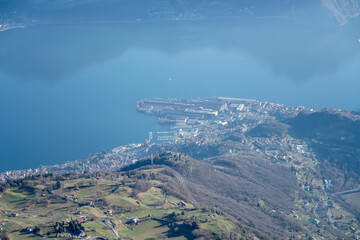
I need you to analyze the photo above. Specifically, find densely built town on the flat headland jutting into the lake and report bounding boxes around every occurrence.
[137,97,305,142]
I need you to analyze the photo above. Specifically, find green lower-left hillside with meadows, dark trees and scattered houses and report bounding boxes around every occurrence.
[0,168,240,240]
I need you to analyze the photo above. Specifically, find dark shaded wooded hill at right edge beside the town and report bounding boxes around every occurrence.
[283,109,360,190]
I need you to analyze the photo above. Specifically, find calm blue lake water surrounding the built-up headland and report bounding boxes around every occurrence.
[0,23,360,171]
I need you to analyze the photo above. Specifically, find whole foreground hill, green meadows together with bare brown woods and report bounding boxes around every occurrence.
[0,147,352,239]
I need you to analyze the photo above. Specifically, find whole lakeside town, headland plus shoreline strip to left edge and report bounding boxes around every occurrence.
[0,97,305,181]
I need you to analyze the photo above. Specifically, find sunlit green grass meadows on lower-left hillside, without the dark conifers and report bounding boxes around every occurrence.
[0,169,234,240]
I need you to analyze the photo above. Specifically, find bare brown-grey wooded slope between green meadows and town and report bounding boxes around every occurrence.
[122,152,301,239]
